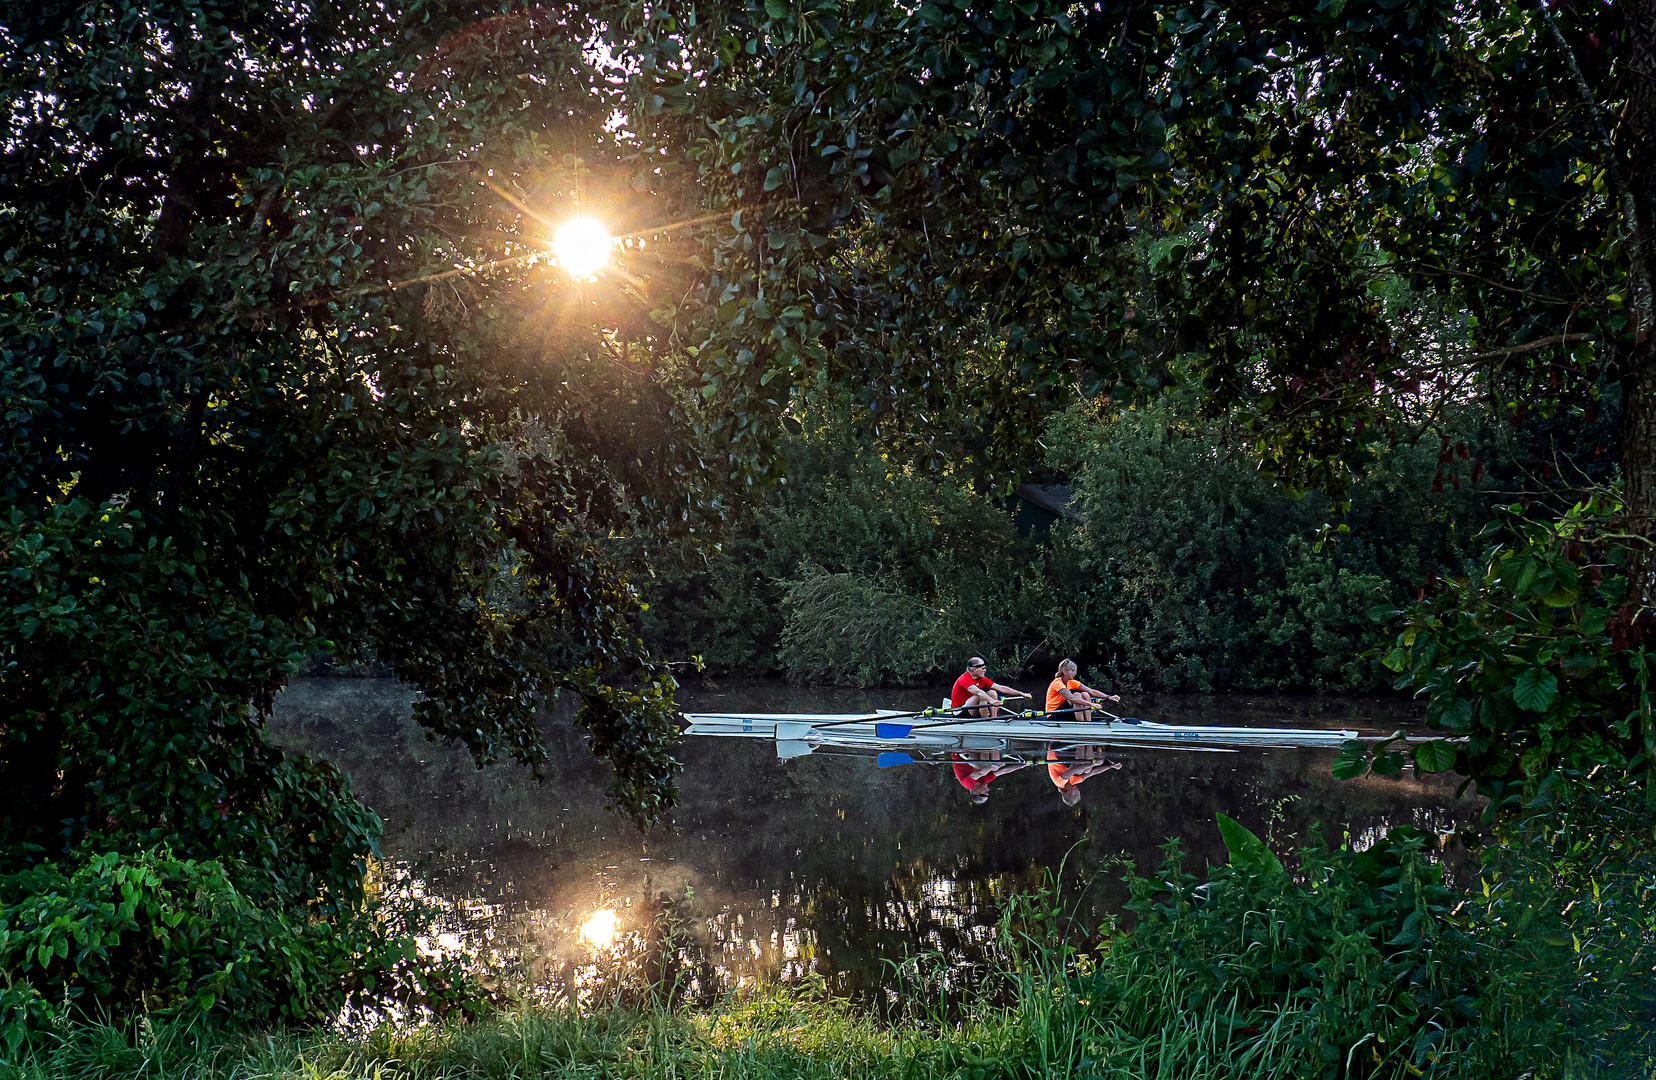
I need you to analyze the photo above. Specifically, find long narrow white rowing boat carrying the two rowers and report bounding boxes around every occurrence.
[684,709,1358,757]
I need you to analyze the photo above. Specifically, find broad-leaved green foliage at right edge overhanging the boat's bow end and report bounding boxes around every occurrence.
[1336,492,1656,800]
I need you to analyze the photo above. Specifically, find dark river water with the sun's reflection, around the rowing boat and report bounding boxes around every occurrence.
[272,679,1477,1004]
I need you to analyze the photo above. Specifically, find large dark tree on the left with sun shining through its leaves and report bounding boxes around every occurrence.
[0,0,751,987]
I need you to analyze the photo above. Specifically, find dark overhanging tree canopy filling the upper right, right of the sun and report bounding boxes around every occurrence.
[625,0,1656,791]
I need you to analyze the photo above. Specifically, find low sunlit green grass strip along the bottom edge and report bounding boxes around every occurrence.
[0,991,1344,1080]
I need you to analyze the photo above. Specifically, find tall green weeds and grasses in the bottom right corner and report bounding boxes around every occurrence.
[977,798,1656,1080]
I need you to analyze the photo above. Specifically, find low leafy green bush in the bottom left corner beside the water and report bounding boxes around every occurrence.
[0,848,477,1052]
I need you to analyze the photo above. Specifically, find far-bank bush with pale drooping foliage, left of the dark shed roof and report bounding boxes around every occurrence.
[641,409,1037,686]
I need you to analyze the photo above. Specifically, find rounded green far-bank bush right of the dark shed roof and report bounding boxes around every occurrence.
[1042,394,1490,691]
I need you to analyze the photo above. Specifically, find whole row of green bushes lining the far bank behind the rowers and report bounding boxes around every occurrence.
[643,394,1522,689]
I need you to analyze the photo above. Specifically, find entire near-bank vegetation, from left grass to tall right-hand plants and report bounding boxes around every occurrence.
[0,777,1656,1080]
